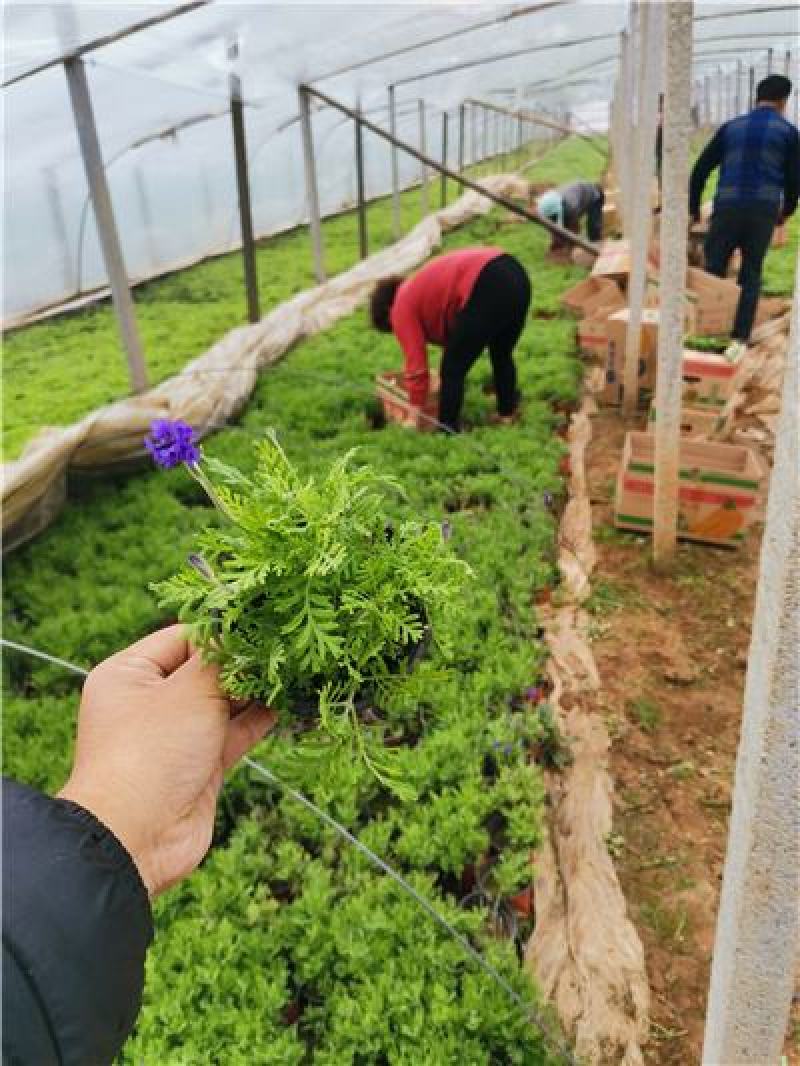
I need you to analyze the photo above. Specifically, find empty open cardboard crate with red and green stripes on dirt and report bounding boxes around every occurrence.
[614,433,767,547]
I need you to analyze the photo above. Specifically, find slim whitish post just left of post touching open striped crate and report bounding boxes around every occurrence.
[622,3,669,416]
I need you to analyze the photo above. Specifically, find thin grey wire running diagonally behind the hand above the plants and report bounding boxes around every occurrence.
[0,637,579,1066]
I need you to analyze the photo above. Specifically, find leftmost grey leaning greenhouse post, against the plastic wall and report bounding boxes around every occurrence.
[64,59,147,392]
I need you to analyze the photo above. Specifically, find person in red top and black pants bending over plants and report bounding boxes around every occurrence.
[370,247,531,432]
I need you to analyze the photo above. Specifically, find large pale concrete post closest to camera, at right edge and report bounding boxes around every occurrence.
[702,289,800,1066]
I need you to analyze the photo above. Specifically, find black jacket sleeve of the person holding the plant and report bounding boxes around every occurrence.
[2,779,153,1066]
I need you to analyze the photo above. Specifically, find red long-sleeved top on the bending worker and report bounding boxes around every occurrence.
[390,247,505,407]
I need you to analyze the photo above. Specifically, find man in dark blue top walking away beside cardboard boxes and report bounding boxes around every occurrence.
[689,74,800,343]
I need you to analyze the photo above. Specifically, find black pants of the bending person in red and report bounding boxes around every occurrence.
[438,256,530,431]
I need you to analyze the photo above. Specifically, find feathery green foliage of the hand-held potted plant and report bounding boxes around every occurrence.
[154,436,468,791]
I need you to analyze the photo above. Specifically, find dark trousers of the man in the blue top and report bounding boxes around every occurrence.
[705,207,778,341]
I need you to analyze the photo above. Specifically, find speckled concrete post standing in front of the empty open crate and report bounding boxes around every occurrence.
[653,0,693,568]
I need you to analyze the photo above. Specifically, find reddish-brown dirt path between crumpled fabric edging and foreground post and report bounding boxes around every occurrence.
[588,410,800,1066]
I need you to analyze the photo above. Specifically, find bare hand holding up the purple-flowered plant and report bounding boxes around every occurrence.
[60,626,275,897]
